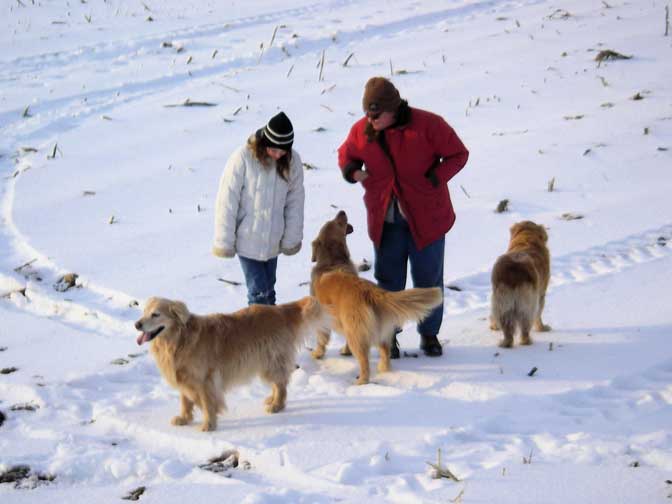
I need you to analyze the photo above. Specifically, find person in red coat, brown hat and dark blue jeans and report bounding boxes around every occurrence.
[338,77,469,358]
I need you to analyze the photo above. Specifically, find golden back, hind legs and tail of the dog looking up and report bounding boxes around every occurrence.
[315,271,443,385]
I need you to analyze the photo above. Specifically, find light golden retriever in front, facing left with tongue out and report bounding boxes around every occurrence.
[135,297,329,431]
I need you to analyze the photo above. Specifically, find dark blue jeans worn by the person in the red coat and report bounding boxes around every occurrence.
[374,205,446,336]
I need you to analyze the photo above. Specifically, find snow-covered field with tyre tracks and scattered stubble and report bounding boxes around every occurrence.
[0,0,672,504]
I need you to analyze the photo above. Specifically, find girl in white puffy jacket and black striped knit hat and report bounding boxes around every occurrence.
[212,112,305,305]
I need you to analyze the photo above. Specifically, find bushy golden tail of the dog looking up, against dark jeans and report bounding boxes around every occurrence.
[376,287,443,327]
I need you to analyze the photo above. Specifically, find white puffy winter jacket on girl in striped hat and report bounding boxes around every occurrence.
[213,145,305,261]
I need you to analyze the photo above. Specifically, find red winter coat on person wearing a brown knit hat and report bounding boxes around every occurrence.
[338,108,469,249]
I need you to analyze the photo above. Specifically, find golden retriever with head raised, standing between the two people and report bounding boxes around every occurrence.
[311,211,443,385]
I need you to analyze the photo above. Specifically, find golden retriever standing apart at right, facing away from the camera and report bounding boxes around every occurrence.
[490,221,551,348]
